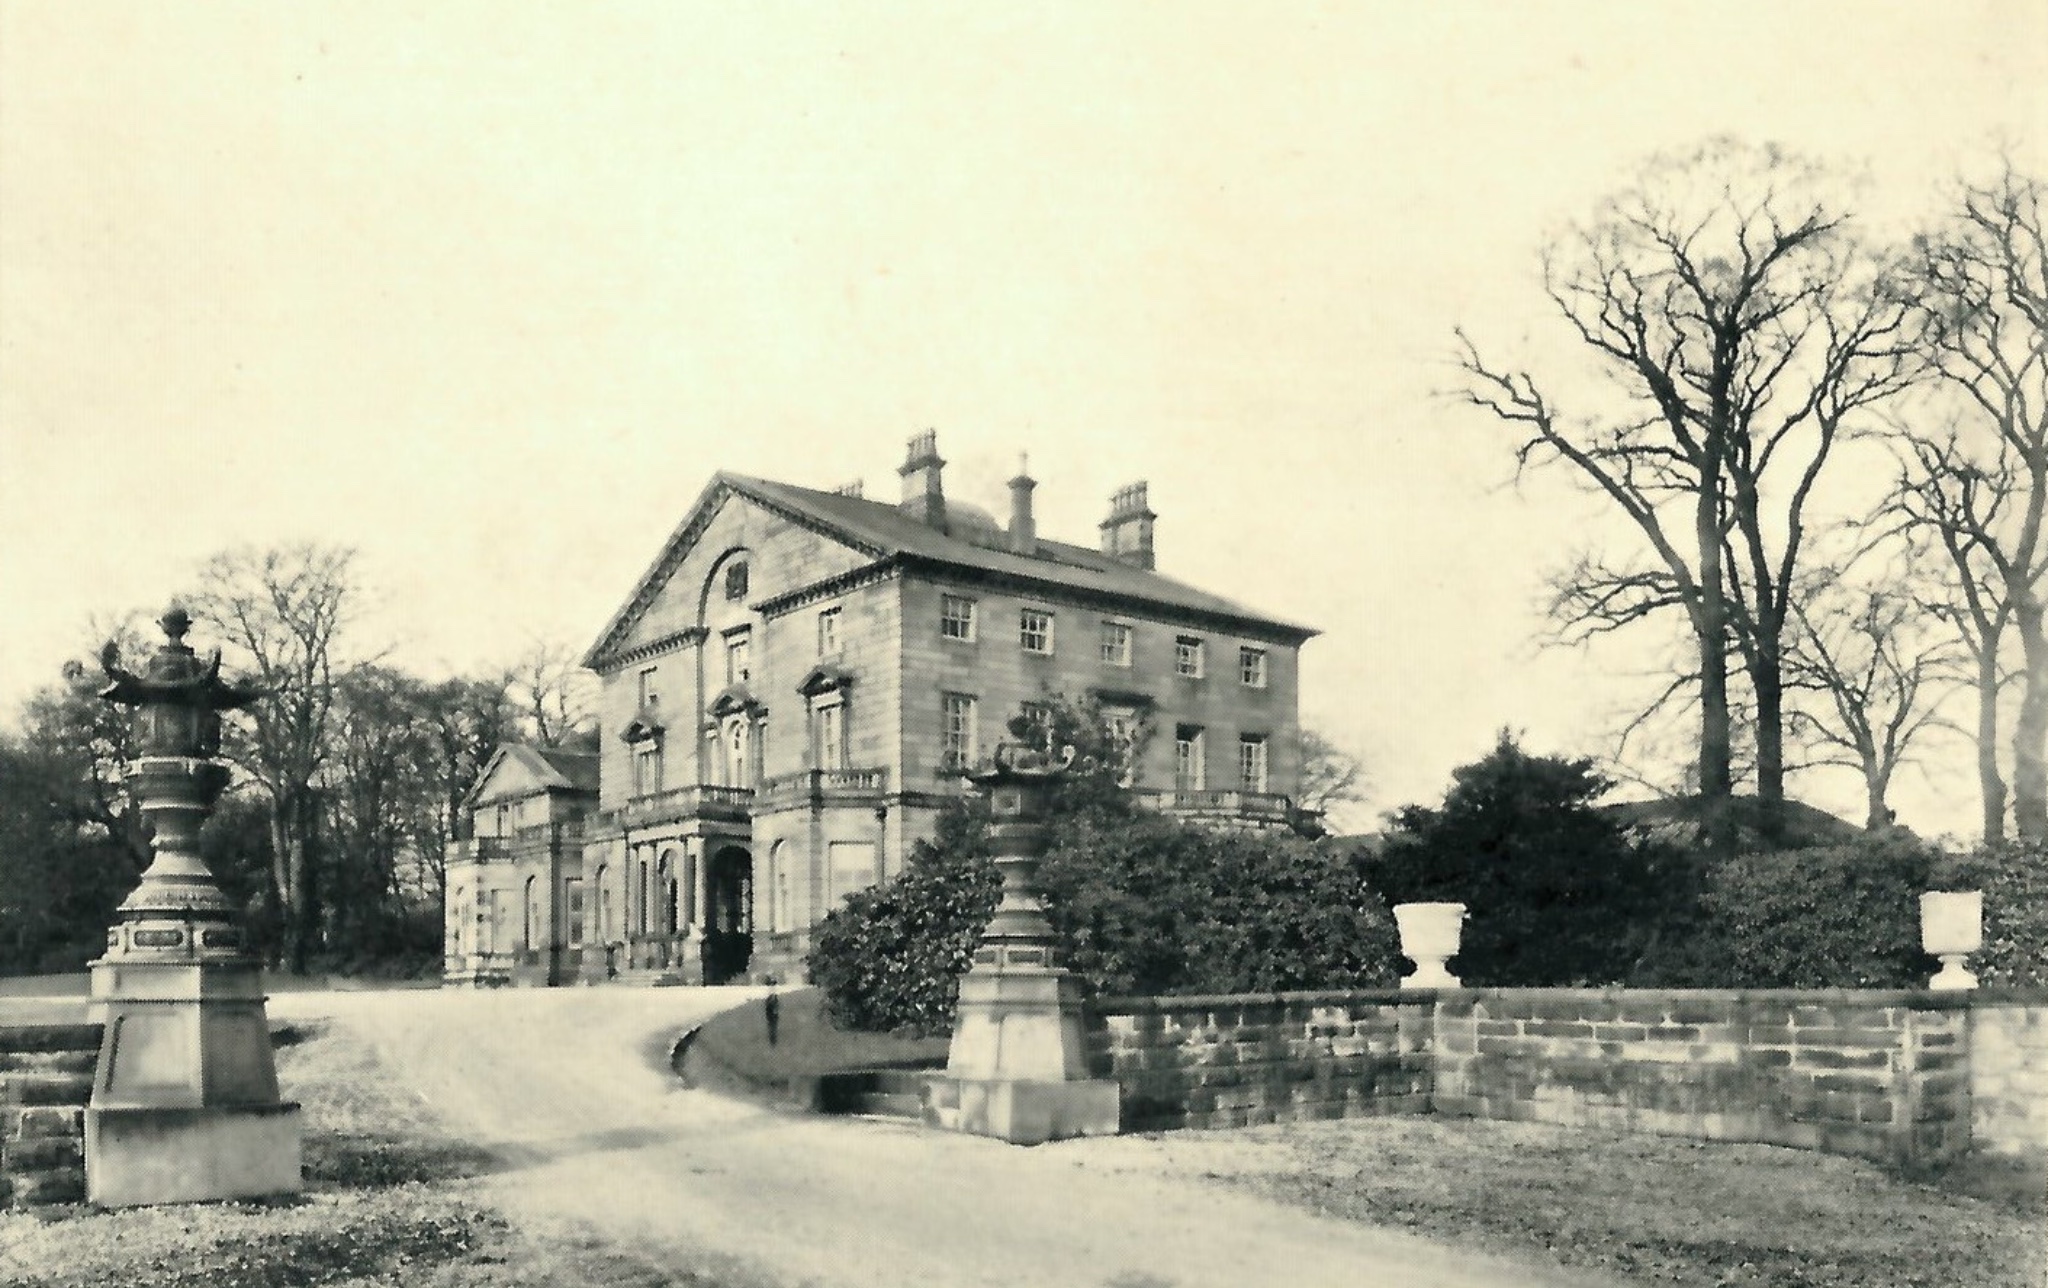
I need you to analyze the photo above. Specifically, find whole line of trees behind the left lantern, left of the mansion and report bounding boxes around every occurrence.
[0,545,594,973]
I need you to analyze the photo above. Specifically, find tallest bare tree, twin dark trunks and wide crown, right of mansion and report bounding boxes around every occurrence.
[1458,141,1913,842]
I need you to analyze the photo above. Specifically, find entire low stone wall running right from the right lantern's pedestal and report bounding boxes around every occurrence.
[1090,989,2023,1165]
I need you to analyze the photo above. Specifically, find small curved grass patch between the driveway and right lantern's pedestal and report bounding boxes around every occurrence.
[684,989,946,1100]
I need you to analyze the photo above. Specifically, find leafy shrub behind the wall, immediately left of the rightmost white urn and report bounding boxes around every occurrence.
[1694,833,1939,989]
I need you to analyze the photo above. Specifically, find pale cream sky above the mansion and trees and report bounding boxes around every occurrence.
[0,0,2048,831]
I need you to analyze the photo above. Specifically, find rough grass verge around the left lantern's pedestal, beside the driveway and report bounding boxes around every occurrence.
[0,1026,765,1288]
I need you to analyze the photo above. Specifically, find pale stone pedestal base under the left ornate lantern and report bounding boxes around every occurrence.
[86,946,303,1208]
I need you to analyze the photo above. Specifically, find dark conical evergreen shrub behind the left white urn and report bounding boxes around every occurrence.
[1364,731,1694,987]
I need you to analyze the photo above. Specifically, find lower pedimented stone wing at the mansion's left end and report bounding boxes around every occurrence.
[442,745,602,985]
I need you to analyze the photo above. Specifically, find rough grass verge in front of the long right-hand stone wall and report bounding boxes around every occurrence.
[1155,1118,2048,1288]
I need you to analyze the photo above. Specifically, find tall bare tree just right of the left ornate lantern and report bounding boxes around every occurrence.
[193,545,356,975]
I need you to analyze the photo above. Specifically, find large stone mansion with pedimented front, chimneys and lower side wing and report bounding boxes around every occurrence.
[446,432,1315,983]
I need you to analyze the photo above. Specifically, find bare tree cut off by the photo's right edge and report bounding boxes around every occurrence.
[1890,164,2048,840]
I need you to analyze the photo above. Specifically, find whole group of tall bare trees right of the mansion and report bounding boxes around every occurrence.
[1454,141,2048,846]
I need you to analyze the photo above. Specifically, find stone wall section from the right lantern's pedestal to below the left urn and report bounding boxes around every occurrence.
[1090,991,1432,1130]
